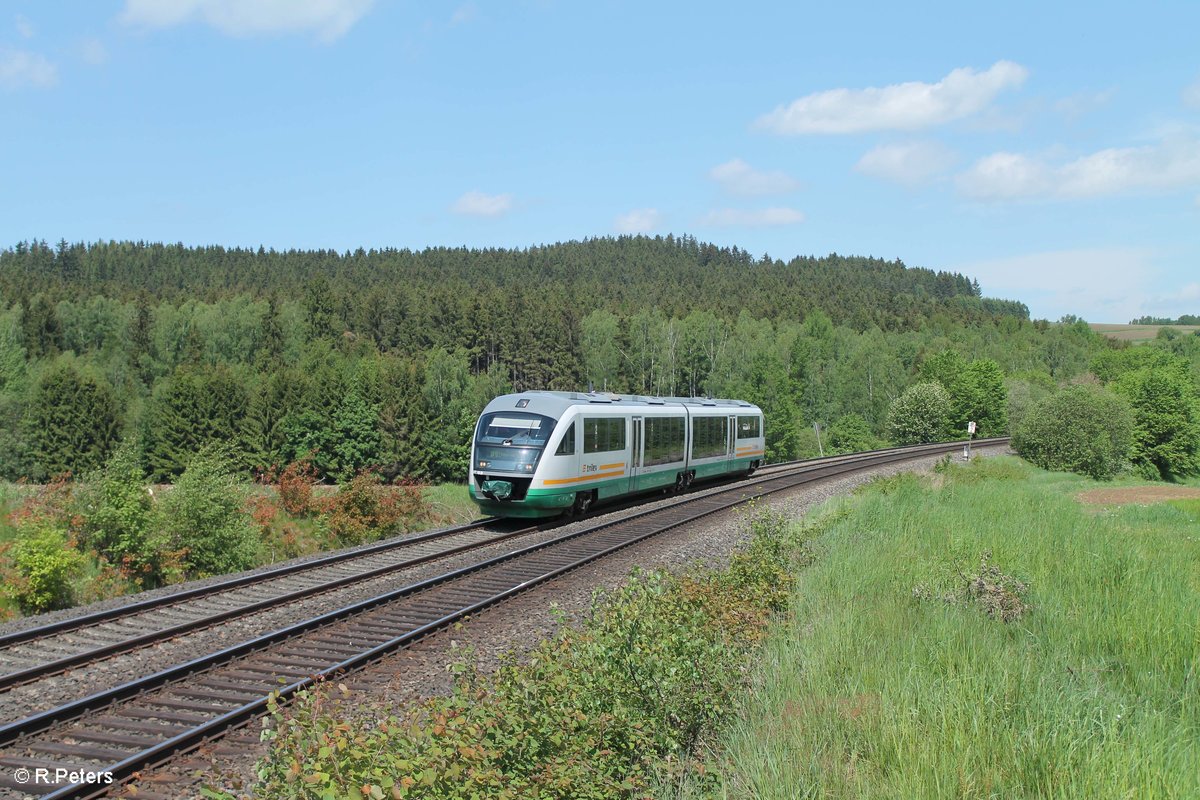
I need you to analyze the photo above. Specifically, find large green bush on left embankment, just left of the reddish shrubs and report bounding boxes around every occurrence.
[155,446,258,577]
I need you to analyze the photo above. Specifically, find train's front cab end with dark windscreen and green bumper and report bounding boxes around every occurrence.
[469,410,563,517]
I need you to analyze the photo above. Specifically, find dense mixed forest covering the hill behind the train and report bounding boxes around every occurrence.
[0,236,1198,482]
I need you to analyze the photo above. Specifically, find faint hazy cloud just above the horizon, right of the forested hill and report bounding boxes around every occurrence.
[950,248,1156,323]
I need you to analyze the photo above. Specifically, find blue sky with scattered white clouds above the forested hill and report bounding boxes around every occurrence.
[0,0,1200,323]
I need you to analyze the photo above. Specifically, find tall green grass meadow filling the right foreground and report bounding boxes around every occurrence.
[700,459,1200,800]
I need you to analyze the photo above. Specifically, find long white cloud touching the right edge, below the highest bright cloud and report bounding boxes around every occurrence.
[958,139,1200,200]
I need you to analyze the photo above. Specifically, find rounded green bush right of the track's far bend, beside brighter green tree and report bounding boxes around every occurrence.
[1013,386,1133,480]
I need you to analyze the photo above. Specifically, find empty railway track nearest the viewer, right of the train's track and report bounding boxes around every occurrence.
[0,439,1004,800]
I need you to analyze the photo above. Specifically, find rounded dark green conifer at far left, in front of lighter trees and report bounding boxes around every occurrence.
[25,363,121,480]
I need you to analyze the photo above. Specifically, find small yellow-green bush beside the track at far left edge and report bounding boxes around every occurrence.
[4,523,86,614]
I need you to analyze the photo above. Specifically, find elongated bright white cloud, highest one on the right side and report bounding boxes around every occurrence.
[755,61,1028,134]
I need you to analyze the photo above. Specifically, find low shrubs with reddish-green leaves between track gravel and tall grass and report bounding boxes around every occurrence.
[254,510,794,800]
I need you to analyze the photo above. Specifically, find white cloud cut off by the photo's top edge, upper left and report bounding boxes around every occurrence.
[121,0,374,42]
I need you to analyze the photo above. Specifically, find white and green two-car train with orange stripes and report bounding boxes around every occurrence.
[468,391,766,517]
